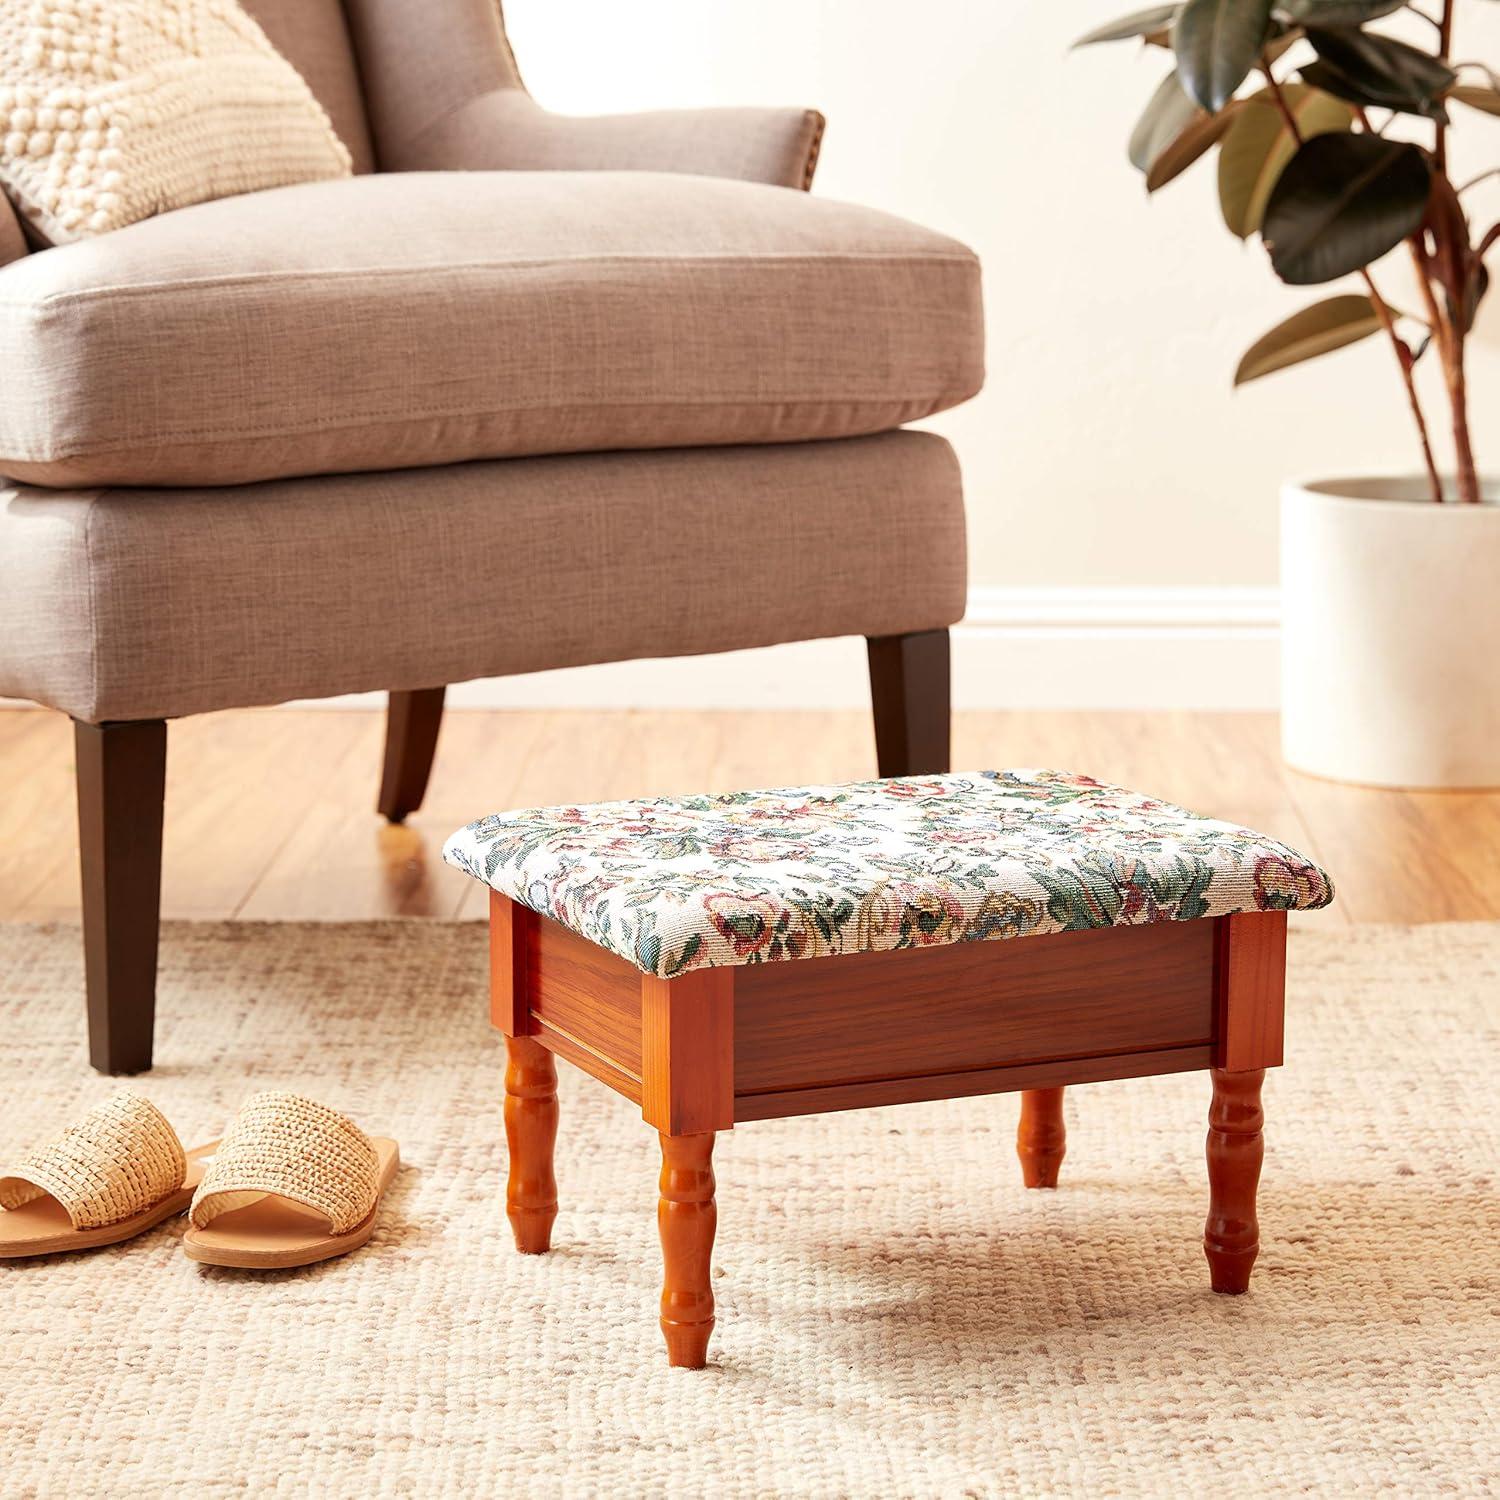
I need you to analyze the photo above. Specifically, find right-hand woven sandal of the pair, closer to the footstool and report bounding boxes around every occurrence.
[183,1092,401,1271]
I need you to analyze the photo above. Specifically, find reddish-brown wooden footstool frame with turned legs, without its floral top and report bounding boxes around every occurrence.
[491,893,1287,1368]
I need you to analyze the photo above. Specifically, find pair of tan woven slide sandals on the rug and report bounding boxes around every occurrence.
[0,1092,401,1271]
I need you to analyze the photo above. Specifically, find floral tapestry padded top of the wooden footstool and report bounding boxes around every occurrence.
[443,771,1334,978]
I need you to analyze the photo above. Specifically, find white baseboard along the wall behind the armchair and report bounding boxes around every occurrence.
[0,588,1280,710]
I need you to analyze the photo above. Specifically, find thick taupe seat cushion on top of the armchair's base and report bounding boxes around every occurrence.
[0,173,983,486]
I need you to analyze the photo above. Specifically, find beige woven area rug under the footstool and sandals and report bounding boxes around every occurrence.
[0,923,1500,1497]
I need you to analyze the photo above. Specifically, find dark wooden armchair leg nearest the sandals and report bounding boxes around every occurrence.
[74,719,167,1073]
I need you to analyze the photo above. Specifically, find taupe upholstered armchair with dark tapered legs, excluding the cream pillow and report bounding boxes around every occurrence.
[0,0,983,1073]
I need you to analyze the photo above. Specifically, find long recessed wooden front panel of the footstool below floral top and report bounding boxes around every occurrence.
[735,921,1215,1097]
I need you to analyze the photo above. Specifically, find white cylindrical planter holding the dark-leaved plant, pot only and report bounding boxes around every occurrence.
[1281,479,1500,788]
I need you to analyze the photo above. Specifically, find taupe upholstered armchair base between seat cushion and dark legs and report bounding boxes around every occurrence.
[0,432,966,723]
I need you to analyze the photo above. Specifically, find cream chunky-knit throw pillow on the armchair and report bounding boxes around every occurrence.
[0,0,350,245]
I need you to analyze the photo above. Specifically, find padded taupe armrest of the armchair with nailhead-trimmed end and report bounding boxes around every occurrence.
[386,89,824,189]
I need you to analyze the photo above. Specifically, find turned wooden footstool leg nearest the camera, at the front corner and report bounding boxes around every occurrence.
[657,1131,719,1370]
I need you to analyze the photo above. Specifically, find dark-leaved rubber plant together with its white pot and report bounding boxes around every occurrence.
[1079,0,1500,786]
